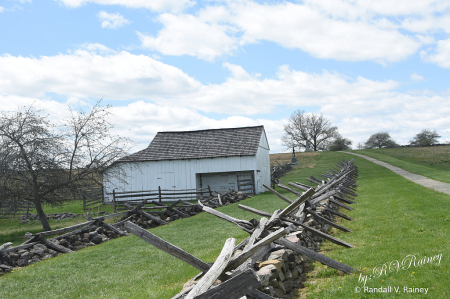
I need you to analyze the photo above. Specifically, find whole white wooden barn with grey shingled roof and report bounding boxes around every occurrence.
[103,126,270,202]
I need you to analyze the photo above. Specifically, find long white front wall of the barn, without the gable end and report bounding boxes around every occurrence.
[104,156,256,202]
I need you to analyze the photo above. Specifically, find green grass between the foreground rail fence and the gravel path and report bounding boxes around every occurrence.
[305,155,450,298]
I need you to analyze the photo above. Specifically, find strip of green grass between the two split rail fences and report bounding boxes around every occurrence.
[0,154,322,298]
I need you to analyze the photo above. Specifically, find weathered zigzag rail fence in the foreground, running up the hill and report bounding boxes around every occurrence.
[125,160,357,299]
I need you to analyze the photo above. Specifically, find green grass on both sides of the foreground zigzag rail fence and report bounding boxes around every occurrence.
[0,152,450,299]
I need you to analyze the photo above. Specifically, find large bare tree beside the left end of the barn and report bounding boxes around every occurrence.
[0,101,130,231]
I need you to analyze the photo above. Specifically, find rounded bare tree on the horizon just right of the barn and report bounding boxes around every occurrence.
[282,110,338,151]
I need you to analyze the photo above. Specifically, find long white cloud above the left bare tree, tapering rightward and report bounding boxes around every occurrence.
[0,44,201,100]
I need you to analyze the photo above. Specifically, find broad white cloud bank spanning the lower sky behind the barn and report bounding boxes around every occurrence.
[0,49,450,152]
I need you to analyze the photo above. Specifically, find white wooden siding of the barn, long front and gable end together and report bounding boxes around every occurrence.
[104,130,270,202]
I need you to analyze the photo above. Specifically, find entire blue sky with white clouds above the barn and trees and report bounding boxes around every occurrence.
[0,0,450,153]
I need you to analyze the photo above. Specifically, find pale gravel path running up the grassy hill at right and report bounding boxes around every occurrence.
[341,152,450,194]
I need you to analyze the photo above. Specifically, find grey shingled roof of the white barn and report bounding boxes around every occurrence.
[117,126,264,162]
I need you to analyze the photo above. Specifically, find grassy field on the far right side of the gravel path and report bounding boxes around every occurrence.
[352,146,450,183]
